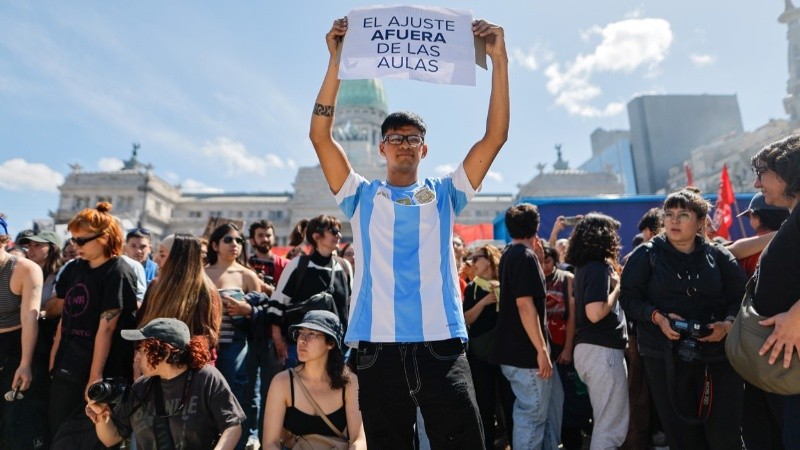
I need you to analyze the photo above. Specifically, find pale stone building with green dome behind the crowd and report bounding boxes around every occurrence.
[51,80,512,246]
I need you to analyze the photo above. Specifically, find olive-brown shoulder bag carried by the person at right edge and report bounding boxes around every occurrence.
[725,294,800,395]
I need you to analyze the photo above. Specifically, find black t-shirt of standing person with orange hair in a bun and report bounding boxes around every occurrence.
[54,258,136,382]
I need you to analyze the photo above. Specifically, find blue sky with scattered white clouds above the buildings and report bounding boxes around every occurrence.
[0,0,787,236]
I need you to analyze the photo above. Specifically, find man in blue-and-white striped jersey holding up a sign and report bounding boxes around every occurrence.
[310,12,510,449]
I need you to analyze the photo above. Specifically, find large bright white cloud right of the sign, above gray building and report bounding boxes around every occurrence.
[544,18,673,117]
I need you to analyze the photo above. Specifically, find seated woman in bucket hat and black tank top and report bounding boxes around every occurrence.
[262,311,366,450]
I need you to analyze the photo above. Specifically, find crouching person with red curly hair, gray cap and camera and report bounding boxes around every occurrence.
[85,318,245,450]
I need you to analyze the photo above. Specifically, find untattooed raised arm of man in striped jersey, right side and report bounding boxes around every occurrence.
[464,20,511,189]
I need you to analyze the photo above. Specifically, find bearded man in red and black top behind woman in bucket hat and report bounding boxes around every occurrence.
[248,219,289,448]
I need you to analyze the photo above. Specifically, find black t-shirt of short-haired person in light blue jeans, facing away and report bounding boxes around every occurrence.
[489,244,547,369]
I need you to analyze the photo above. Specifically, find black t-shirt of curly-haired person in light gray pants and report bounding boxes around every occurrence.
[575,261,628,349]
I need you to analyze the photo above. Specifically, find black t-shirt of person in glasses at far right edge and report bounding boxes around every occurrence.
[753,207,800,317]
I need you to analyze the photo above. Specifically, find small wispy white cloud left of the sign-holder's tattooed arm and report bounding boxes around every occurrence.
[203,137,287,176]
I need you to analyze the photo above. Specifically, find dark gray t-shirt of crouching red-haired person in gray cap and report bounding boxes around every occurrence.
[112,365,245,450]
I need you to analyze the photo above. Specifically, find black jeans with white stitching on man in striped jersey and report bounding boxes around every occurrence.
[358,338,484,450]
